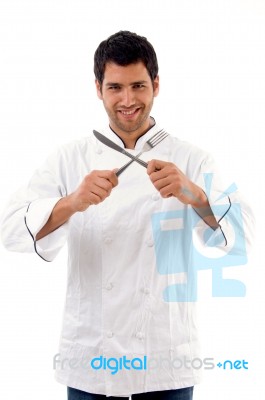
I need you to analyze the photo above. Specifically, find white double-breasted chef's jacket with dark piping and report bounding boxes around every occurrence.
[2,125,251,396]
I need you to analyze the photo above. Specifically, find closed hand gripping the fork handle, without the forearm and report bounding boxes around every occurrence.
[69,171,118,212]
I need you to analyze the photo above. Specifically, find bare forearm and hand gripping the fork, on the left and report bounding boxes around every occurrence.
[36,170,118,240]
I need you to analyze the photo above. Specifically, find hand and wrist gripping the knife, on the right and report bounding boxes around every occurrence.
[147,160,206,208]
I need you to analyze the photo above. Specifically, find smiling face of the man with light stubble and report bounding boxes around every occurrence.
[96,62,159,139]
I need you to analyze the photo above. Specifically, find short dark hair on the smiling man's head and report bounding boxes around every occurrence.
[94,31,158,85]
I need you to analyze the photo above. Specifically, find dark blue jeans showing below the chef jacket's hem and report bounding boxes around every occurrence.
[67,386,193,400]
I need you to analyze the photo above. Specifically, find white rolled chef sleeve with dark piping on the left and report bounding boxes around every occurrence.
[1,150,68,261]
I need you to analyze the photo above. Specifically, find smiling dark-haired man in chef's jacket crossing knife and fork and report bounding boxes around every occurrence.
[2,31,252,400]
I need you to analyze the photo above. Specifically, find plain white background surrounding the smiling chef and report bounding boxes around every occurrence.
[0,0,265,400]
